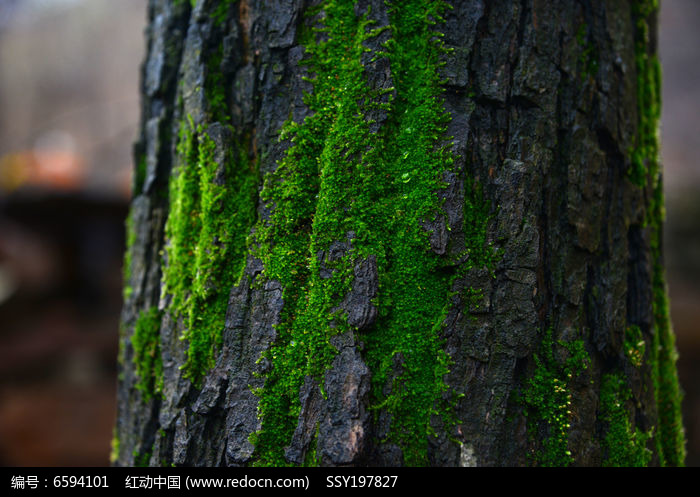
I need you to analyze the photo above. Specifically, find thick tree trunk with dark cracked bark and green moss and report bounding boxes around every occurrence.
[113,0,684,466]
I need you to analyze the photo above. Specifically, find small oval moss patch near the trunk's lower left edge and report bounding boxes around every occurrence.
[131,307,163,399]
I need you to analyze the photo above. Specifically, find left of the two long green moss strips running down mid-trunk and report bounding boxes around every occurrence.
[250,2,378,465]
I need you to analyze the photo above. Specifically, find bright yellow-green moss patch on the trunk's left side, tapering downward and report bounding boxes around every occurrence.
[163,118,257,382]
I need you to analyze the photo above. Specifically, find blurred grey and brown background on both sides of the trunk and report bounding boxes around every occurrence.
[0,0,700,466]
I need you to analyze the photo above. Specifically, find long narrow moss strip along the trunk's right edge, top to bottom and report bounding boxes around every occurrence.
[629,0,685,466]
